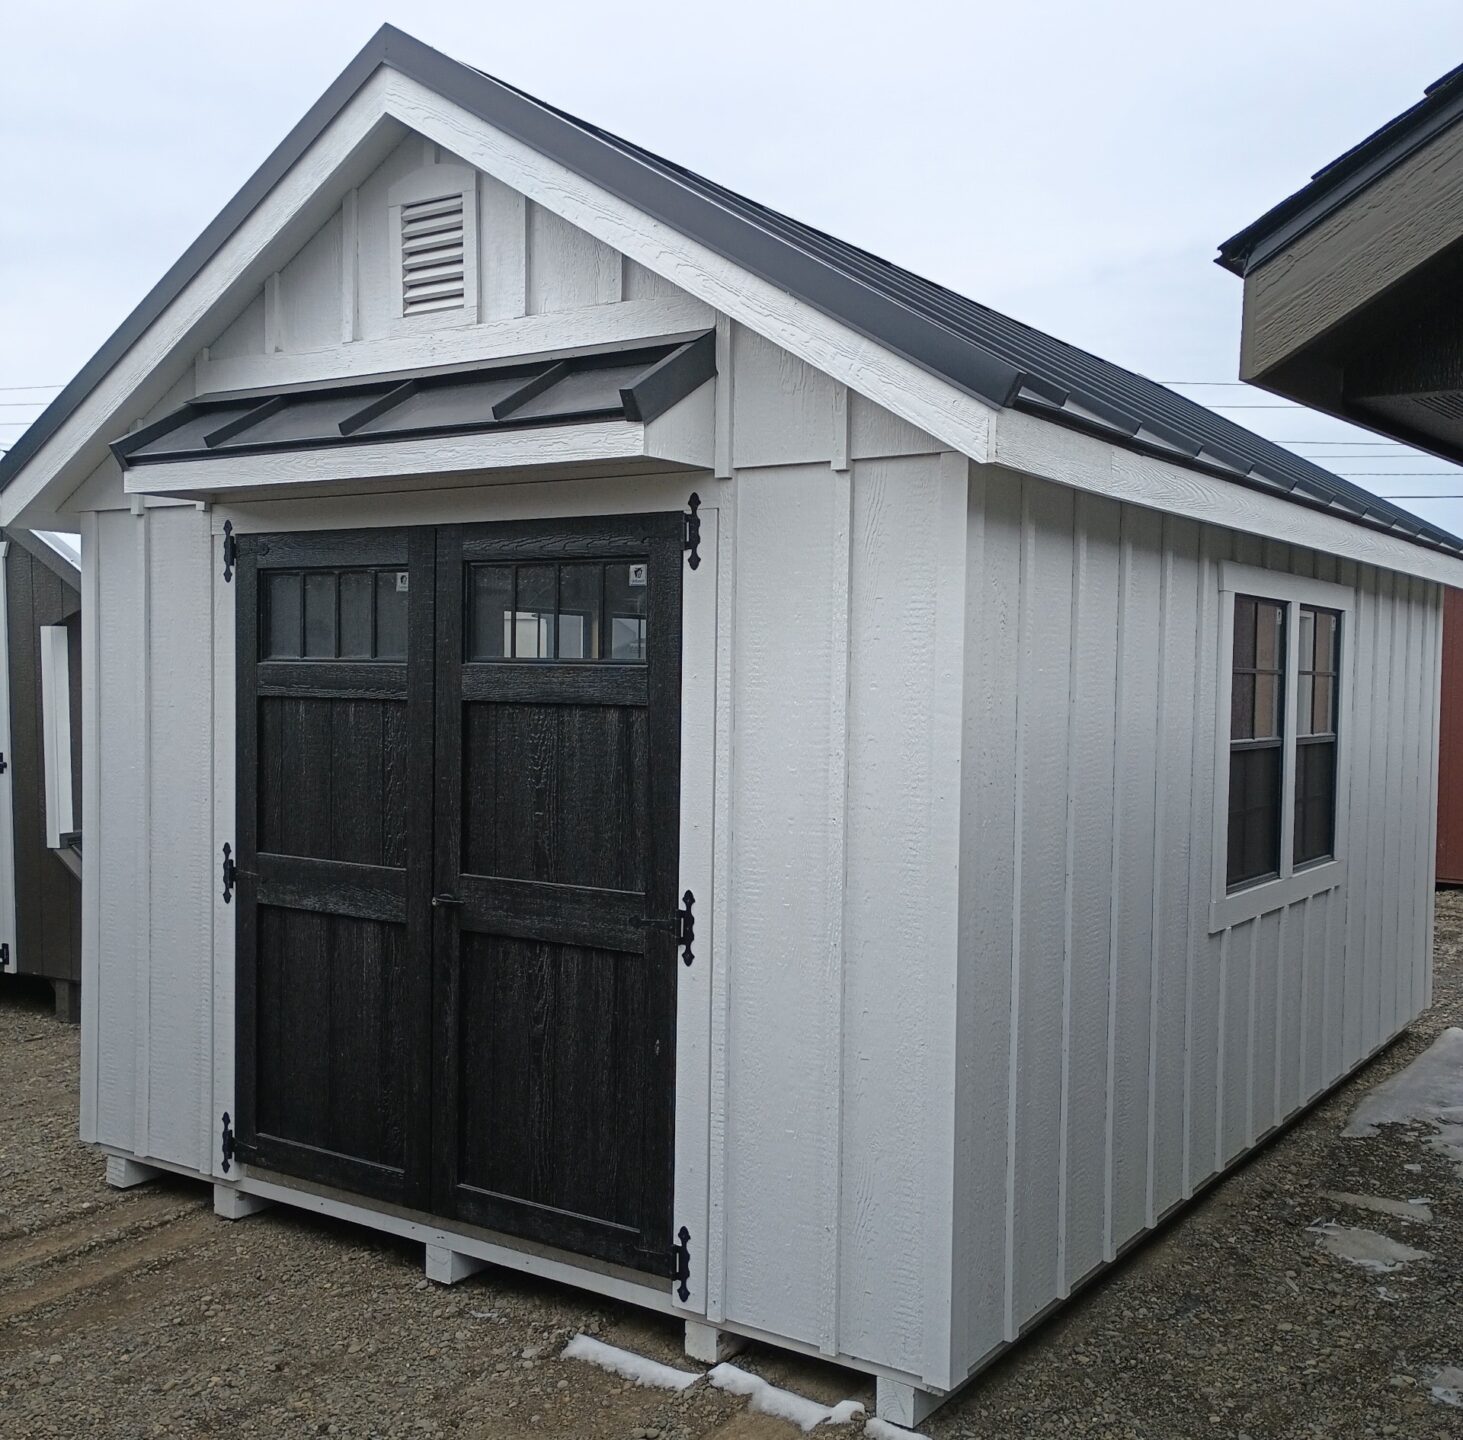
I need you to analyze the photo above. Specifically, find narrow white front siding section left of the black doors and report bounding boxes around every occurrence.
[82,505,218,1174]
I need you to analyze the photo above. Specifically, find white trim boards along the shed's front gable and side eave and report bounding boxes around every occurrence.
[0,54,1463,584]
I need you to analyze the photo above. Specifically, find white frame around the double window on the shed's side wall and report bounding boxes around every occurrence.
[1208,560,1356,934]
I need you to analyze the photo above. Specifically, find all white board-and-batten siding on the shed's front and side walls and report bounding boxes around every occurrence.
[83,292,1440,1387]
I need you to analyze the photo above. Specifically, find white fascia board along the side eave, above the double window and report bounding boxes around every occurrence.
[989,410,1463,585]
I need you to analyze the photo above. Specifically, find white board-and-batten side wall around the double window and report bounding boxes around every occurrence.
[951,467,1441,1381]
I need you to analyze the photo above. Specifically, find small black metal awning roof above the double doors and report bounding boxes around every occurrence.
[111,331,715,467]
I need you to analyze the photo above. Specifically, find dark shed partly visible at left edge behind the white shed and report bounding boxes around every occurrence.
[0,528,82,1021]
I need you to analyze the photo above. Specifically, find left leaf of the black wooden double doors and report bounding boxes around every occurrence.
[236,531,435,1209]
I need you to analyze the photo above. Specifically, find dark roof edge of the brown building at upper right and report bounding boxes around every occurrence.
[1217,64,1463,275]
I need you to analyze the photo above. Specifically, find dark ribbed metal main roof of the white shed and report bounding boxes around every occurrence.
[0,25,1463,555]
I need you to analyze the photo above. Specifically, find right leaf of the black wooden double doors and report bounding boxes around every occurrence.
[433,515,683,1275]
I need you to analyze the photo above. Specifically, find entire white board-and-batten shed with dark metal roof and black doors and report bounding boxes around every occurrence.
[0,28,1463,1422]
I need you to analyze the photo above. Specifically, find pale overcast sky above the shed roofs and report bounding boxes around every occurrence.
[0,0,1463,533]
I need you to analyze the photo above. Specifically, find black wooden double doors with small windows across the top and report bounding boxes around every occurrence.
[236,514,683,1273]
